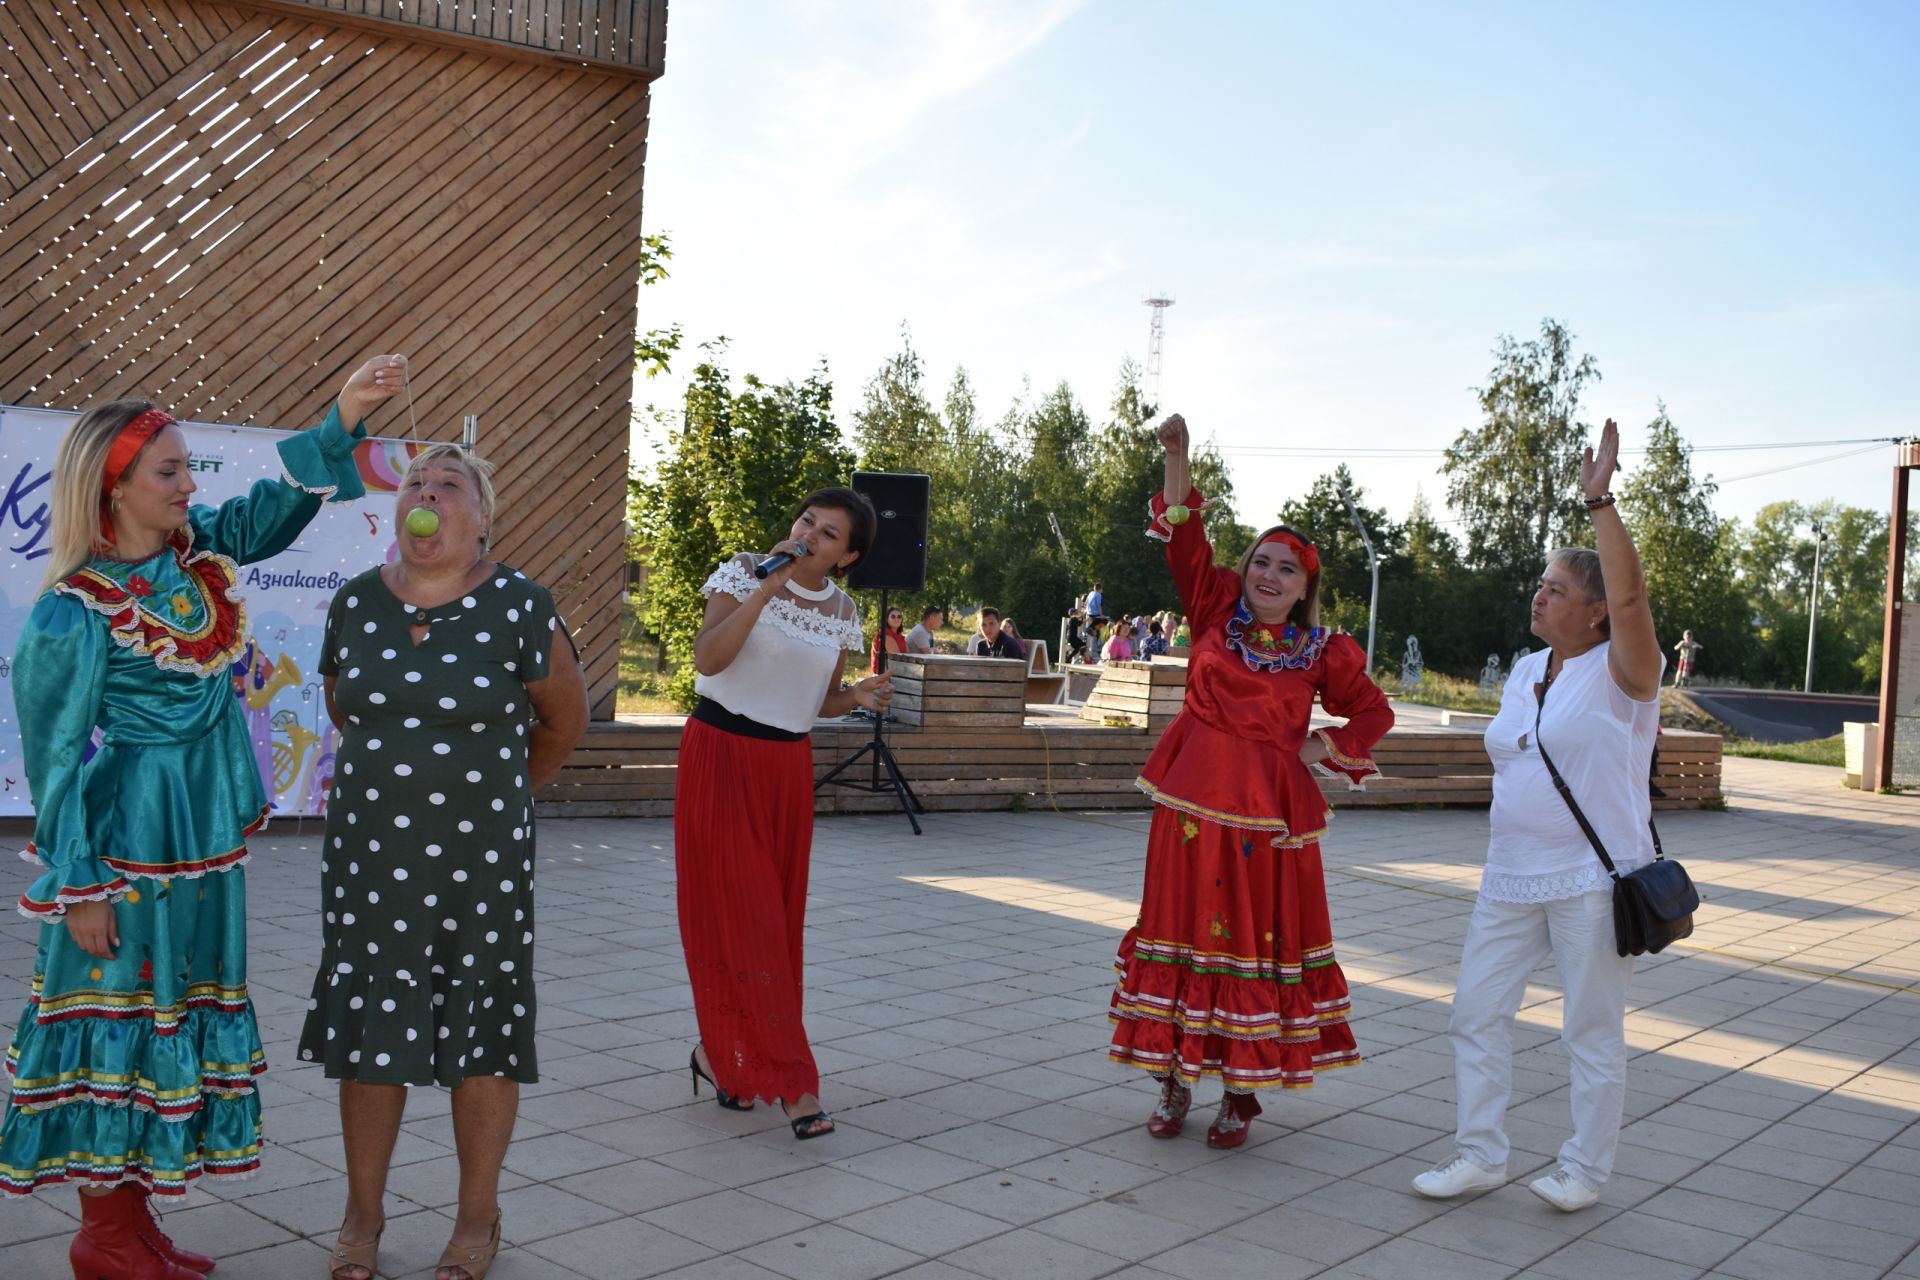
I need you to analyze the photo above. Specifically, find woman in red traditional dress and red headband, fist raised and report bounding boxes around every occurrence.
[1108,415,1394,1148]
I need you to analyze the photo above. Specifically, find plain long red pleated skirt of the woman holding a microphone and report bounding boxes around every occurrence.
[674,720,820,1102]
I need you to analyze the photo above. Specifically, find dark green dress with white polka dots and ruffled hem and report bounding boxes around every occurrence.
[300,564,559,1084]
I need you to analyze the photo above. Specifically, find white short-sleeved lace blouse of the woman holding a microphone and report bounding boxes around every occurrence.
[693,555,864,733]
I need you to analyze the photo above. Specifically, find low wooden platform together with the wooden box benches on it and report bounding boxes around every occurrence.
[538,656,1722,818]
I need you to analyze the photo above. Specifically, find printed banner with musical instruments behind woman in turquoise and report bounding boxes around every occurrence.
[0,405,422,816]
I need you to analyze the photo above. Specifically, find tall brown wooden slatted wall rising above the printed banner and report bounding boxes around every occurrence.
[0,0,666,716]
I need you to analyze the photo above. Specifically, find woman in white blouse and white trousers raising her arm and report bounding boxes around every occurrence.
[1413,418,1665,1211]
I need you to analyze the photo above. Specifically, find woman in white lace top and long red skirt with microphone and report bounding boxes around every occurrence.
[674,487,893,1138]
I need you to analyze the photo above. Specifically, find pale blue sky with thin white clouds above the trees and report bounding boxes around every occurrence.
[636,0,1920,522]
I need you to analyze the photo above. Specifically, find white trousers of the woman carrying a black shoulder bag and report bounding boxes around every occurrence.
[1448,889,1634,1186]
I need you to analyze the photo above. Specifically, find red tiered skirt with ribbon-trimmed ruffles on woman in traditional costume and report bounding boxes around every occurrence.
[1108,806,1359,1092]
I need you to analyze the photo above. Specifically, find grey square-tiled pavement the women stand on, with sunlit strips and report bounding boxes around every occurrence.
[0,760,1920,1280]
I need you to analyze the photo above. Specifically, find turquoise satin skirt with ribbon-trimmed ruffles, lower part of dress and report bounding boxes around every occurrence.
[0,865,267,1196]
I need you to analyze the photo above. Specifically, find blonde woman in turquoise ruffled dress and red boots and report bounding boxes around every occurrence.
[0,355,403,1280]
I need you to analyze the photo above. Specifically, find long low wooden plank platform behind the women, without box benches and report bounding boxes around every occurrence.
[538,717,1720,818]
